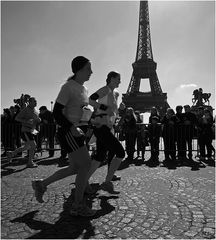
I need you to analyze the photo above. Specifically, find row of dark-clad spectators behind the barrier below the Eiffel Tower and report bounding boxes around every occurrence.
[116,105,215,168]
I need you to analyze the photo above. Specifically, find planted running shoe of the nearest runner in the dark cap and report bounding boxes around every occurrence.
[69,204,97,217]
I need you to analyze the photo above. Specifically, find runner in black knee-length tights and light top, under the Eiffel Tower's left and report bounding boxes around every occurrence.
[89,71,125,193]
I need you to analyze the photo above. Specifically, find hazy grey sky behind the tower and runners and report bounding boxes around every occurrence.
[1,1,215,112]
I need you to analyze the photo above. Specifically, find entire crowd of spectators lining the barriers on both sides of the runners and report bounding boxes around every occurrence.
[1,94,215,167]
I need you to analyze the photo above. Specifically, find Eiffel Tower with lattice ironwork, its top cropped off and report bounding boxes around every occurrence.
[122,1,169,115]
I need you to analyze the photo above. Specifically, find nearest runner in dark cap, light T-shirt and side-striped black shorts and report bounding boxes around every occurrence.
[32,56,96,217]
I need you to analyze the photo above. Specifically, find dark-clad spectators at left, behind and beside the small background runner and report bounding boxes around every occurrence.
[1,94,56,157]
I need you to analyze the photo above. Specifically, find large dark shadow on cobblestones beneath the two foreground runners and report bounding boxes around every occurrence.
[11,189,118,239]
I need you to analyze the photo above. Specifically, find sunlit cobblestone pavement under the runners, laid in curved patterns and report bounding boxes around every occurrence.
[1,153,215,239]
